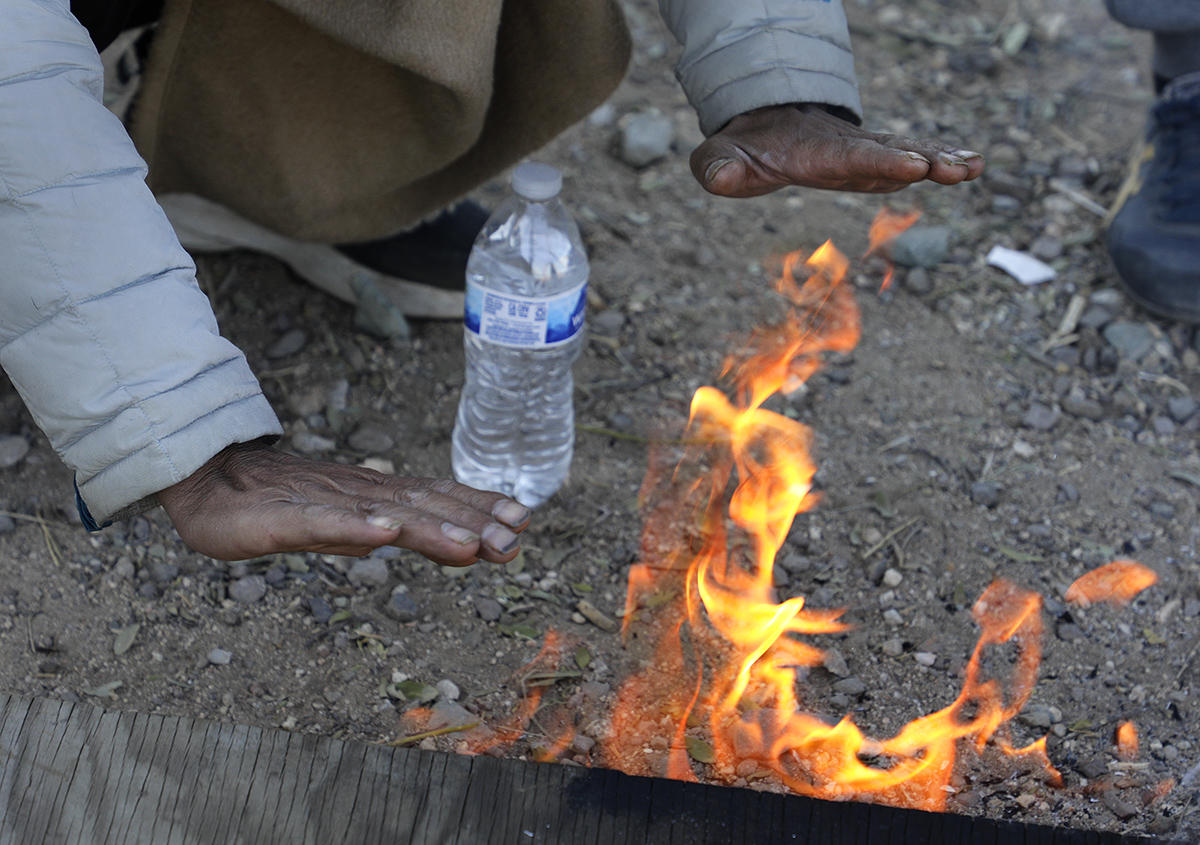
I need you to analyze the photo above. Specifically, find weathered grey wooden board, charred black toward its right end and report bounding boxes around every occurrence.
[0,695,1153,845]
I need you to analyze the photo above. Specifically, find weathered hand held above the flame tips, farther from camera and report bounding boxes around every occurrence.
[691,104,983,197]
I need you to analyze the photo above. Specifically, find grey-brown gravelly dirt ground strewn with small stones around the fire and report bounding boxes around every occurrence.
[0,0,1200,840]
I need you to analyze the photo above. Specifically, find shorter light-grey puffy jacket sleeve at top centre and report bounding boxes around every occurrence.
[659,0,863,136]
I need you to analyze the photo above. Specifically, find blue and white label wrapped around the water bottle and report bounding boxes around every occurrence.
[463,281,588,349]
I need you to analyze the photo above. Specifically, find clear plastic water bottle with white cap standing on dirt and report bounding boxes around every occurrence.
[451,162,588,508]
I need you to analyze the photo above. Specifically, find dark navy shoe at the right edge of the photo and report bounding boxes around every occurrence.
[1108,72,1200,323]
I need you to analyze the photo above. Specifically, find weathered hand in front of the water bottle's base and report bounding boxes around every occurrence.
[158,443,529,567]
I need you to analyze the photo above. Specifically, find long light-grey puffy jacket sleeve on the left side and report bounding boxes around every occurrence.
[0,0,280,522]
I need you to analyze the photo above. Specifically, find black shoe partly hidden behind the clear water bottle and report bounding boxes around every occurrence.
[334,199,487,290]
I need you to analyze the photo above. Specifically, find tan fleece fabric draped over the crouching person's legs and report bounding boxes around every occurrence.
[131,0,630,242]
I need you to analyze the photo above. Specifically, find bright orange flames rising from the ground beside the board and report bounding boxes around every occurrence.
[451,215,1154,810]
